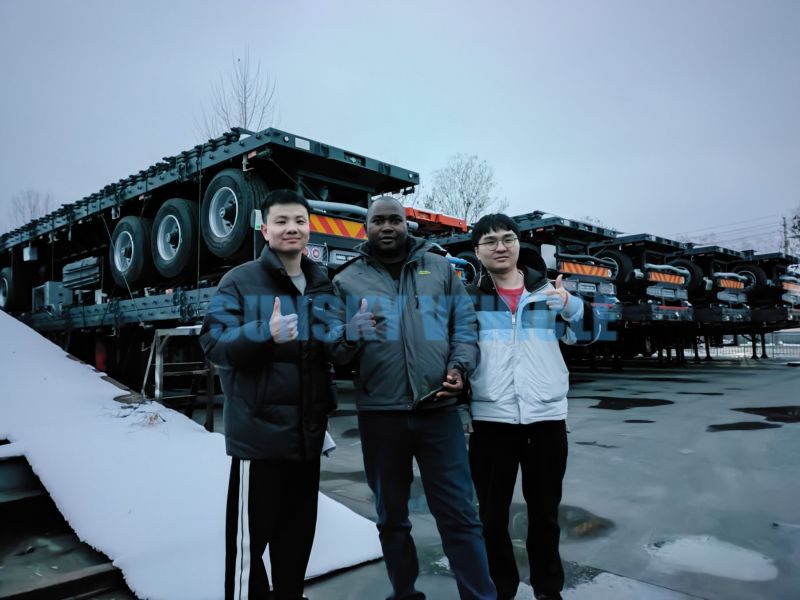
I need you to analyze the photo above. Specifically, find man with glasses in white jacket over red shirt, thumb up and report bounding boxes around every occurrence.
[468,214,591,600]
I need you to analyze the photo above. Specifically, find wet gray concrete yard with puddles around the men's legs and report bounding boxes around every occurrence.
[306,359,800,600]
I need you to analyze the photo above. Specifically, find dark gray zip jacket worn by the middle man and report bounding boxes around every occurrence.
[332,236,478,411]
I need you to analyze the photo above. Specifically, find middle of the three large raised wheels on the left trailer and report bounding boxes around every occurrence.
[150,198,198,279]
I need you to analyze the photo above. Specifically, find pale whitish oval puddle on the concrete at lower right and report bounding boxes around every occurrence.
[645,535,778,581]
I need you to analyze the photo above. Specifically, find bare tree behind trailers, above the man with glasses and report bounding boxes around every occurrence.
[422,154,508,223]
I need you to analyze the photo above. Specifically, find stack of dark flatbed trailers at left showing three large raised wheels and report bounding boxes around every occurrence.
[0,129,424,390]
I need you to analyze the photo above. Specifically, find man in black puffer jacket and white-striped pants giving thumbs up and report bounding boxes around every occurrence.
[200,190,335,600]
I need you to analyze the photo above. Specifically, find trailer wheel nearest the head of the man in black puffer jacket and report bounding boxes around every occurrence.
[200,169,267,258]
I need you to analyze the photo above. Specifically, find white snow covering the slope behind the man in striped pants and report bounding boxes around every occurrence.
[0,311,381,600]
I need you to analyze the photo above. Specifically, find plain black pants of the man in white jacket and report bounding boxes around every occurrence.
[469,421,567,599]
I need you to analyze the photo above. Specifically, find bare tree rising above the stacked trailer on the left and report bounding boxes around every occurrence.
[196,46,275,138]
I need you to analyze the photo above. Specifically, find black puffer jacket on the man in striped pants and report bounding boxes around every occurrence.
[200,247,335,461]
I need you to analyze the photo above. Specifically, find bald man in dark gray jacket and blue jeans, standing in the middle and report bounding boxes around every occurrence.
[333,196,496,600]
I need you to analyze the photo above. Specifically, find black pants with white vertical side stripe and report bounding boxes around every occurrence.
[225,458,319,600]
